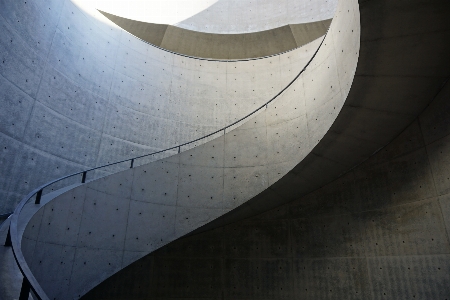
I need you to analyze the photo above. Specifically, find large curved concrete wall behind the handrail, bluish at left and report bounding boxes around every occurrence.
[0,0,330,213]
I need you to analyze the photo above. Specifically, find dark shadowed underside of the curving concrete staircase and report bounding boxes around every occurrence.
[192,0,450,231]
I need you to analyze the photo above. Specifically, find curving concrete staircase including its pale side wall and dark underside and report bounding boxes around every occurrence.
[2,0,448,299]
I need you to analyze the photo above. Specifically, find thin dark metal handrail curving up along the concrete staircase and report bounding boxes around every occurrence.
[5,31,328,300]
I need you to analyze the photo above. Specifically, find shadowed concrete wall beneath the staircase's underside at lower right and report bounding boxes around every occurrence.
[83,72,450,299]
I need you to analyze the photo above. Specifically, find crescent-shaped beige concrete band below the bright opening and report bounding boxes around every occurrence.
[100,11,331,59]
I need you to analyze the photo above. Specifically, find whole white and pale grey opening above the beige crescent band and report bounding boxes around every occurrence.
[92,0,337,34]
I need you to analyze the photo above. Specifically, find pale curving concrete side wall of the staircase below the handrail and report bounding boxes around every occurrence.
[17,1,359,299]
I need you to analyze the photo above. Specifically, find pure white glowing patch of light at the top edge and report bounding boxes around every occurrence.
[84,0,218,25]
